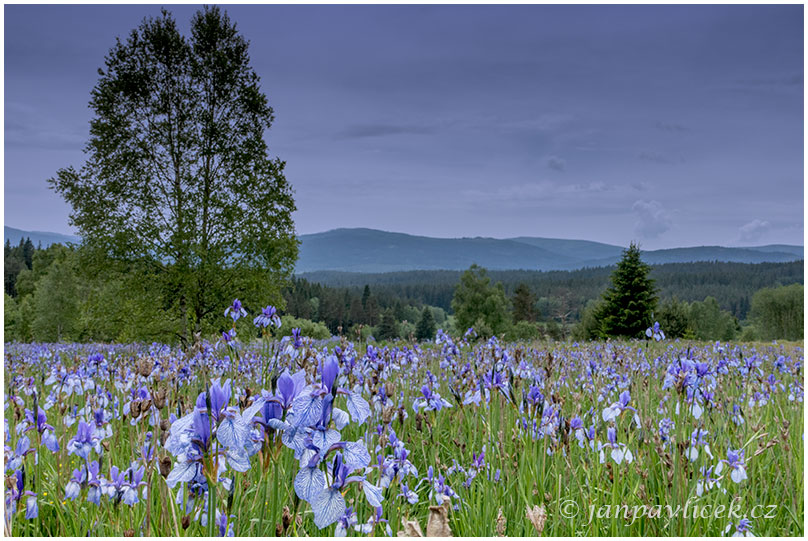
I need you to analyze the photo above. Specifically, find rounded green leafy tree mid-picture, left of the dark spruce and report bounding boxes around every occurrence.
[452,265,510,337]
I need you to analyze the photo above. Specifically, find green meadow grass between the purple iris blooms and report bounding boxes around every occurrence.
[4,341,804,536]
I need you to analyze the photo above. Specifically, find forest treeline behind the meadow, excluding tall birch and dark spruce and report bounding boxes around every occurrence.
[4,239,803,342]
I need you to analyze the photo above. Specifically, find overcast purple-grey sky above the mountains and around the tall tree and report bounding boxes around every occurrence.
[4,5,804,249]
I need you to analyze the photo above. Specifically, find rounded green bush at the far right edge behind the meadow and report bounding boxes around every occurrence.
[752,284,805,340]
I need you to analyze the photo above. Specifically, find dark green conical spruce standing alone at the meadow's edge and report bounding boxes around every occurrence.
[596,242,657,338]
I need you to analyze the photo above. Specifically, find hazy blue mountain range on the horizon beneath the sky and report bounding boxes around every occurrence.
[5,226,803,274]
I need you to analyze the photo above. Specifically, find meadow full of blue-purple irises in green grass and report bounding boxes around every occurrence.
[3,302,804,536]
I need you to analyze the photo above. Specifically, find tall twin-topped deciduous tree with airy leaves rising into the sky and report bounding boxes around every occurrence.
[50,7,298,337]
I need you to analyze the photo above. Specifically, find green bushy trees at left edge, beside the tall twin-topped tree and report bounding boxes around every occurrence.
[4,239,177,342]
